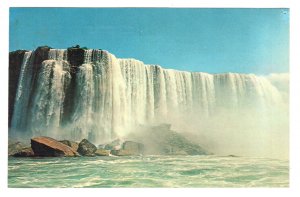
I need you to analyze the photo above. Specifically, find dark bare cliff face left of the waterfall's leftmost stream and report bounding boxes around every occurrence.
[8,50,26,127]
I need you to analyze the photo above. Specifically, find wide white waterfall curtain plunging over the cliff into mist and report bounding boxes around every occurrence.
[9,48,288,158]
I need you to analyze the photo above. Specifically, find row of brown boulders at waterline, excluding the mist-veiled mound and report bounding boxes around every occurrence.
[8,136,144,157]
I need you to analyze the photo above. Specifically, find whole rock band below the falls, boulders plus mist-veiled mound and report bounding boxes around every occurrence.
[8,124,209,157]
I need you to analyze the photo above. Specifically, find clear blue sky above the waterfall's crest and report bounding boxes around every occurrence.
[9,8,289,75]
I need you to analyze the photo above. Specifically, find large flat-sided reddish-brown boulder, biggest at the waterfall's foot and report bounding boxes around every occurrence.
[31,136,78,157]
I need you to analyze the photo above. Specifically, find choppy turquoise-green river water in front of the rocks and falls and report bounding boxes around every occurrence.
[8,156,289,188]
